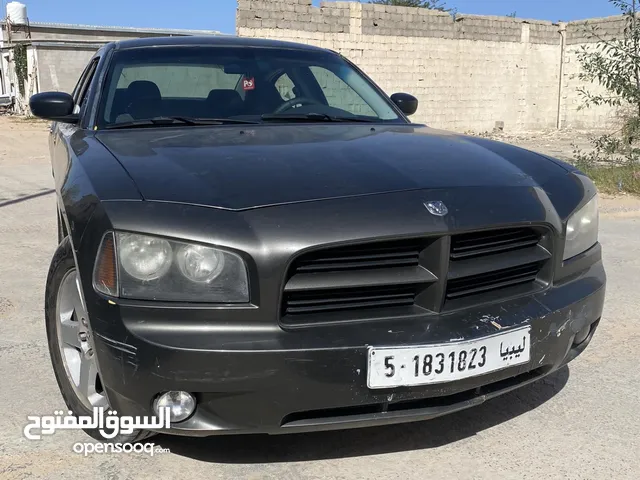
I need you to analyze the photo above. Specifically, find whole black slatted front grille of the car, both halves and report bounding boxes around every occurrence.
[280,227,551,326]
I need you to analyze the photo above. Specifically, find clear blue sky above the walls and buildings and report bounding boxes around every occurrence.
[7,0,619,33]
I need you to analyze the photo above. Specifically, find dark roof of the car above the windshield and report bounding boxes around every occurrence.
[114,35,330,52]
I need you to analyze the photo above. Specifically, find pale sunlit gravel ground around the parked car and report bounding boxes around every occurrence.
[0,117,640,480]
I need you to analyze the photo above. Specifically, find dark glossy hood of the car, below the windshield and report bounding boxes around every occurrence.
[97,124,566,210]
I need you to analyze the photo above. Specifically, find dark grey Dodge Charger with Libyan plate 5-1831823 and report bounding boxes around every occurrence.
[30,37,606,441]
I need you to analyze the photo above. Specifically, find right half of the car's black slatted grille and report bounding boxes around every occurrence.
[444,228,551,309]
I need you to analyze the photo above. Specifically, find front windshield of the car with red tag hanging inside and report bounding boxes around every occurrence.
[98,46,405,128]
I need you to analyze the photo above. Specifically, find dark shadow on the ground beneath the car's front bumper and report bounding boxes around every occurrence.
[159,366,569,464]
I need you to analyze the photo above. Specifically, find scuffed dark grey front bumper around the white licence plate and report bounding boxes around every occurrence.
[92,261,606,436]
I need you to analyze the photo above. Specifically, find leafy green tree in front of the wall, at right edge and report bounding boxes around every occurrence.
[575,0,640,170]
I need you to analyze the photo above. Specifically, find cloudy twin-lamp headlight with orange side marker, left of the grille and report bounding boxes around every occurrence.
[93,232,249,303]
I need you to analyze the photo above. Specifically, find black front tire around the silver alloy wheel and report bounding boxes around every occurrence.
[45,238,154,443]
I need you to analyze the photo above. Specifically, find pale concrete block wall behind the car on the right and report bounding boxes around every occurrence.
[236,0,632,131]
